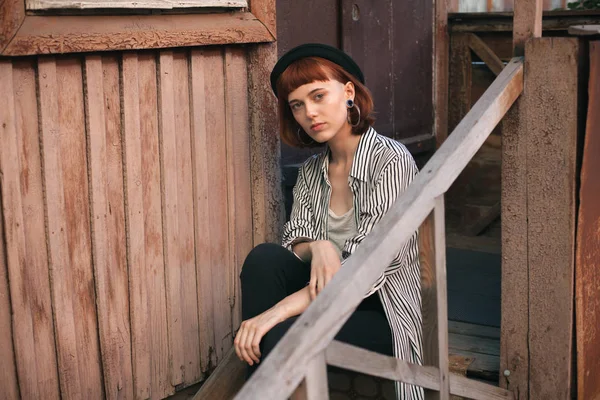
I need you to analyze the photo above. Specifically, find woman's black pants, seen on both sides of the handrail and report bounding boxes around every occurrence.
[240,243,393,375]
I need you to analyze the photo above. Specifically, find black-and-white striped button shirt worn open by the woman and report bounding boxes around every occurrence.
[282,128,424,400]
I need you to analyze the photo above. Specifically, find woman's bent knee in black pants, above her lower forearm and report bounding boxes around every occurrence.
[240,243,310,320]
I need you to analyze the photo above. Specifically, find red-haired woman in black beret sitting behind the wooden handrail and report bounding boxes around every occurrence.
[234,44,423,399]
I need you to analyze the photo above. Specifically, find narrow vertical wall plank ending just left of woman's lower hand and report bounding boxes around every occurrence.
[204,49,232,363]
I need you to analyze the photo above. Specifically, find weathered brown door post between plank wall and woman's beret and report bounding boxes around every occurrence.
[247,44,285,246]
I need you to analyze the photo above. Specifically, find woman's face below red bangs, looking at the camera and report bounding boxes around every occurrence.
[288,79,354,143]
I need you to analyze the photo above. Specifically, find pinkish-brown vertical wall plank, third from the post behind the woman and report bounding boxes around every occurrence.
[159,51,199,386]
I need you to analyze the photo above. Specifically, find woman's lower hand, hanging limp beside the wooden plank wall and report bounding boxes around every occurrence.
[233,307,285,365]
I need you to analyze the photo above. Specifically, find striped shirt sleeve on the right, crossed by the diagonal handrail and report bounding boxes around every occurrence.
[342,154,418,297]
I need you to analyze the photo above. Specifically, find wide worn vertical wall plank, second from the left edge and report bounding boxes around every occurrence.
[38,58,103,399]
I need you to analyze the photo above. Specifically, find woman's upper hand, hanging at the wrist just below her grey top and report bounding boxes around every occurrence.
[309,240,342,300]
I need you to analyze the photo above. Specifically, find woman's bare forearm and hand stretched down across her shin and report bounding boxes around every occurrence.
[233,286,311,365]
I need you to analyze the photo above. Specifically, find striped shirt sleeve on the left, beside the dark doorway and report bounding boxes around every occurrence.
[281,167,317,251]
